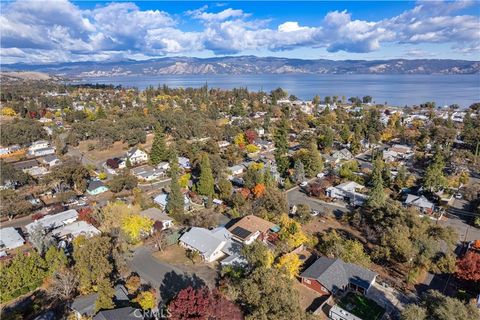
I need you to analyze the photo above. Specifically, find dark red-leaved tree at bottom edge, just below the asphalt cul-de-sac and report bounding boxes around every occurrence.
[168,287,243,320]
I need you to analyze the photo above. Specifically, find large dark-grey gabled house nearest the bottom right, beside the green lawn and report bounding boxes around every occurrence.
[300,257,377,295]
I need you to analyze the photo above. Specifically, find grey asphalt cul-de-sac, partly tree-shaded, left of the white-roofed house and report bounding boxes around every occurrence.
[128,246,215,303]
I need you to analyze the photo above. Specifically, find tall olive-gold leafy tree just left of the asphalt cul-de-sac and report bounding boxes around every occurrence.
[73,236,113,293]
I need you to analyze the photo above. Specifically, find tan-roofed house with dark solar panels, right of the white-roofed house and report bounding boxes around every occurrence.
[228,215,279,245]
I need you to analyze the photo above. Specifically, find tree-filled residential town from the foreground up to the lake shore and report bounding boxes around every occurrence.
[0,77,480,320]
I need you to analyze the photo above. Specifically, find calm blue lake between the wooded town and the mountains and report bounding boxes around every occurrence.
[77,74,480,107]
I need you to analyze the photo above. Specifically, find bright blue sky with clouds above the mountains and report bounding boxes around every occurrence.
[0,0,480,64]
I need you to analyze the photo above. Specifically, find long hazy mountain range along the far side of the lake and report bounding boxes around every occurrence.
[2,56,480,78]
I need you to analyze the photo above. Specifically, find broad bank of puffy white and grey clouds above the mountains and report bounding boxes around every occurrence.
[0,0,480,63]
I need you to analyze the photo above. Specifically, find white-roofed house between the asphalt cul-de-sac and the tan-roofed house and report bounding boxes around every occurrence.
[179,227,241,262]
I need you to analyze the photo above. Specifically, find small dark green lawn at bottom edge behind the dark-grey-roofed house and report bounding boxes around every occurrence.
[338,292,385,320]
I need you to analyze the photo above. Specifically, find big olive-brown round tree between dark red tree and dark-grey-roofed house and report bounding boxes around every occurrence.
[238,268,305,320]
